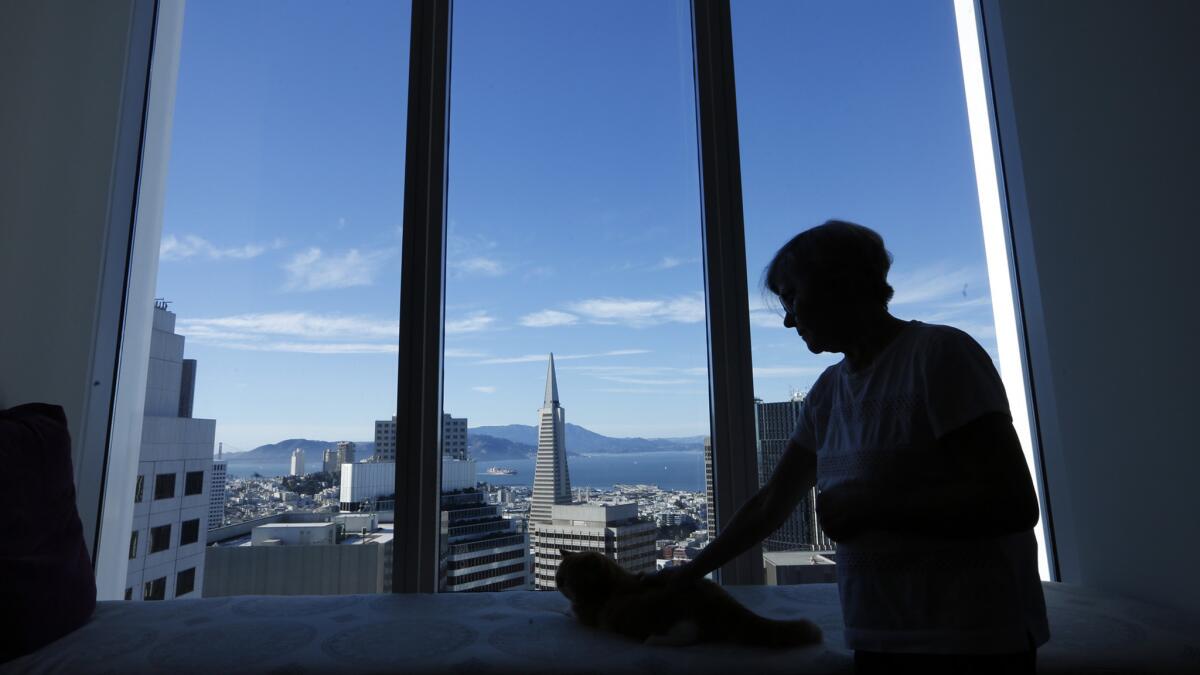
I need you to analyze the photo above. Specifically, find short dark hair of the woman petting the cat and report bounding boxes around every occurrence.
[762,220,894,307]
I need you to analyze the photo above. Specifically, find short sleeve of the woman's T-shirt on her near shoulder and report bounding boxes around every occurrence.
[925,329,1010,438]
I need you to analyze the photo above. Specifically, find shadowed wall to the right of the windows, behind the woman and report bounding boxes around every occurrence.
[984,0,1200,611]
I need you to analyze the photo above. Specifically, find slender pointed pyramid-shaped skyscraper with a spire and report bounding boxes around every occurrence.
[529,354,571,528]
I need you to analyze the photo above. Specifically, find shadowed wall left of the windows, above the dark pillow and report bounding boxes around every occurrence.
[0,0,152,554]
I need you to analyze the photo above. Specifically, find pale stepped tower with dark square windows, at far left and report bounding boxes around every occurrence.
[125,301,216,601]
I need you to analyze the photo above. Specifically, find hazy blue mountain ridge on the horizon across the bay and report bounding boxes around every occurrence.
[224,423,704,458]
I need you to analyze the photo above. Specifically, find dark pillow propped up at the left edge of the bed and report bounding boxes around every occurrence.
[0,404,96,663]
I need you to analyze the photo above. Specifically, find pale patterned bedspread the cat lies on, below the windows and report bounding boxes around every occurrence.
[0,584,1200,675]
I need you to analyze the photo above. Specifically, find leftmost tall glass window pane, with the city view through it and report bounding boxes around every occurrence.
[118,0,410,598]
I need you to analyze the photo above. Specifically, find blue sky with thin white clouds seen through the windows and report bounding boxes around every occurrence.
[157,0,995,449]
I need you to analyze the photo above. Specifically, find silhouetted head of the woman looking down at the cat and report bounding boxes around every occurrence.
[762,220,893,352]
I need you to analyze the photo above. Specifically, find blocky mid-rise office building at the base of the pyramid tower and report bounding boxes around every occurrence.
[530,503,658,591]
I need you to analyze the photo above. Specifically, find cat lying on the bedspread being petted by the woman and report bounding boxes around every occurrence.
[554,550,821,647]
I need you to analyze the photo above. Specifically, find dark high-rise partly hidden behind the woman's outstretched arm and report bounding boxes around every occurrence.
[755,393,834,551]
